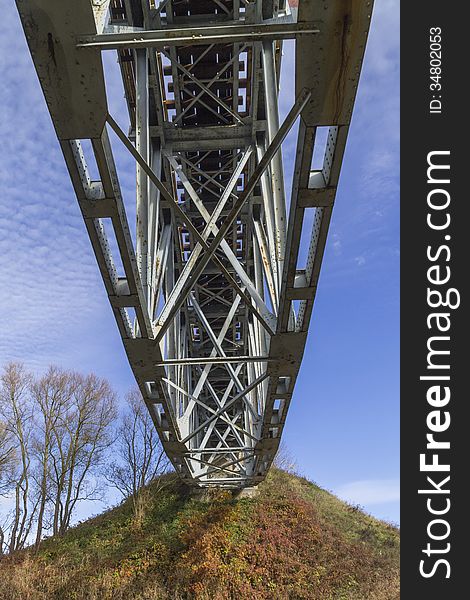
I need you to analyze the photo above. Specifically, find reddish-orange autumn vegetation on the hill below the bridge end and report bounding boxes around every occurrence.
[173,489,398,600]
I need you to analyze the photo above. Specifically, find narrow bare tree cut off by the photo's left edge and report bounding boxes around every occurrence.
[0,363,36,552]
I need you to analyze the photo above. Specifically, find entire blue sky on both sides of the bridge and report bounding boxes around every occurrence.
[0,0,399,522]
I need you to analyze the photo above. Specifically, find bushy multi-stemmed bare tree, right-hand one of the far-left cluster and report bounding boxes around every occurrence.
[49,373,116,534]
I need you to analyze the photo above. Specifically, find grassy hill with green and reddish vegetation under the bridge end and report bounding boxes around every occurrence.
[0,469,399,600]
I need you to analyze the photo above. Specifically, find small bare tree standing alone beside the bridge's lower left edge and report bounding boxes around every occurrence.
[105,389,170,515]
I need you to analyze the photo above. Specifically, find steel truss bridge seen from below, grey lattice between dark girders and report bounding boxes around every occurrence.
[16,0,372,488]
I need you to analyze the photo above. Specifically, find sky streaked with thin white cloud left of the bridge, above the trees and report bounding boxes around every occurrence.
[0,3,135,384]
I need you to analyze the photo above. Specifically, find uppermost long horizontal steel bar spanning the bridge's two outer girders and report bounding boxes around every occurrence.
[77,23,320,50]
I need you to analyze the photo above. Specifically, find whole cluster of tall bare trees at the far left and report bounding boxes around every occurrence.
[0,363,116,553]
